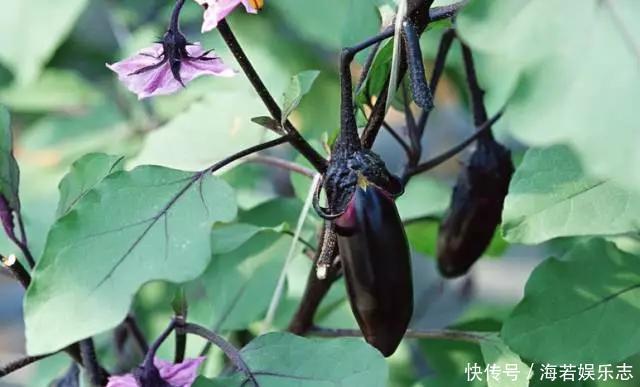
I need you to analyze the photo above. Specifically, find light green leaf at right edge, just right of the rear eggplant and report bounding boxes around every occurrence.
[502,146,640,244]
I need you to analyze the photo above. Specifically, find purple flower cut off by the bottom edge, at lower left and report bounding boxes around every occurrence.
[107,357,204,387]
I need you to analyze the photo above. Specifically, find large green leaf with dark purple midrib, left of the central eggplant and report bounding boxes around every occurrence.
[24,166,236,354]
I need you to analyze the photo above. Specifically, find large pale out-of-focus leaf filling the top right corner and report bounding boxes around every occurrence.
[457,0,640,190]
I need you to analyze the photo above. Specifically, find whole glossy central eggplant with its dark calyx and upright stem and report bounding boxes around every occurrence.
[314,45,413,356]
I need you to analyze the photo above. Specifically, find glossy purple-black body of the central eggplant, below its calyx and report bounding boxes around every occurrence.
[337,185,413,357]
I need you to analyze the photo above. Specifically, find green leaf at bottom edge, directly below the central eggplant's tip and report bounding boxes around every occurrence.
[212,333,388,387]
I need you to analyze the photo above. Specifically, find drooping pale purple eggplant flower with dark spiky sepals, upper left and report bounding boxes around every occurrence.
[107,30,235,99]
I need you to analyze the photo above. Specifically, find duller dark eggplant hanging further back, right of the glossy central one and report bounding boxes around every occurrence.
[437,139,514,278]
